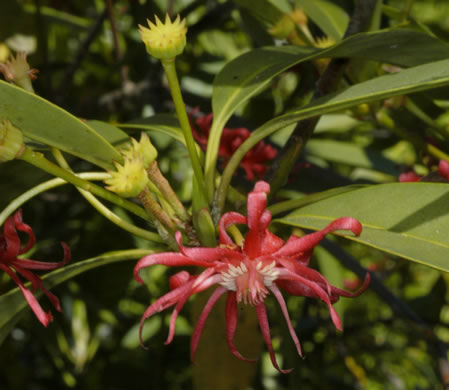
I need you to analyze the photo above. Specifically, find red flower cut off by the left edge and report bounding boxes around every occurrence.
[0,210,70,326]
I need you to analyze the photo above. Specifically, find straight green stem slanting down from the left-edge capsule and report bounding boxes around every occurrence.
[18,147,151,221]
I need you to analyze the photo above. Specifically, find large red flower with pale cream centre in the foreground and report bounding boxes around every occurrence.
[134,181,370,373]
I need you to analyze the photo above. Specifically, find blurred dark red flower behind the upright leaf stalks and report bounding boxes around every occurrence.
[190,112,277,181]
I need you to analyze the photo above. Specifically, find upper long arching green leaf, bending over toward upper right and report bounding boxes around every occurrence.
[205,29,449,193]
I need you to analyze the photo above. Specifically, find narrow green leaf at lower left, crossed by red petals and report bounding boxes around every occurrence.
[0,249,154,343]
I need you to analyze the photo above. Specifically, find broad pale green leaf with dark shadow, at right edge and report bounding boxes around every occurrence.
[276,183,449,272]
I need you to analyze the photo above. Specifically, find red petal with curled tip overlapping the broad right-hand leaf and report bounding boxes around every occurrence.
[273,217,362,256]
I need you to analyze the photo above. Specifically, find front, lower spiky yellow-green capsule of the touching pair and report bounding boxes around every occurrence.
[104,157,148,198]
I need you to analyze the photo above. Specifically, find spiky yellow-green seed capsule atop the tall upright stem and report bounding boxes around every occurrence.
[139,14,187,60]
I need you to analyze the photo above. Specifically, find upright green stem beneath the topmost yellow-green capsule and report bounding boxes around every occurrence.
[161,58,205,203]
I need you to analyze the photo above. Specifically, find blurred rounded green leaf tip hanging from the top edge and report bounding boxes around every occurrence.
[296,0,349,41]
